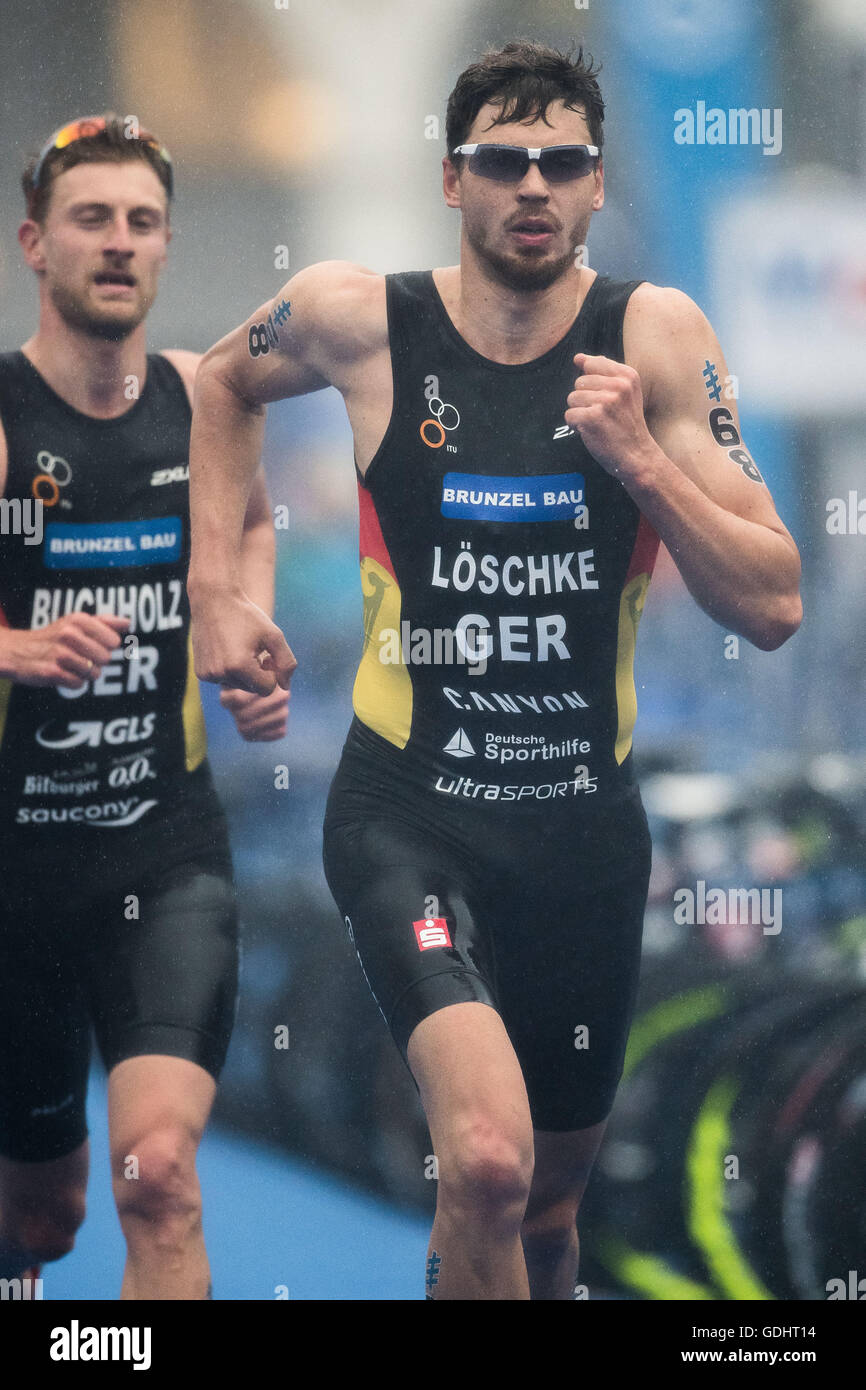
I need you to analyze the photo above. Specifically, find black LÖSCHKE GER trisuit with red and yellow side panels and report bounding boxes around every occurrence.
[324,271,659,1130]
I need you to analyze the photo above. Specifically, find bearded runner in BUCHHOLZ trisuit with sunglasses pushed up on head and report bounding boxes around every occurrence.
[0,113,286,1298]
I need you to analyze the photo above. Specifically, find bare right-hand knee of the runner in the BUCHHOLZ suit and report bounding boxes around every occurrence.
[111,1123,202,1227]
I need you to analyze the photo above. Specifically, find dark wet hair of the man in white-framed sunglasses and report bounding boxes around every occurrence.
[445,39,605,164]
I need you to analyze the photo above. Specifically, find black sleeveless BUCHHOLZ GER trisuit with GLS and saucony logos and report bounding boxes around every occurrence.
[0,352,238,1161]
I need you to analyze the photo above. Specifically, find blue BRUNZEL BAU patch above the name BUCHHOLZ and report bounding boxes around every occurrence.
[42,517,183,570]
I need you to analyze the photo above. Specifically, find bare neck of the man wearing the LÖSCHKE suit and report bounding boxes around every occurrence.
[436,247,595,364]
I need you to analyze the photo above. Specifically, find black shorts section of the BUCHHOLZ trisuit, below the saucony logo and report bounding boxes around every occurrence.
[0,817,238,1162]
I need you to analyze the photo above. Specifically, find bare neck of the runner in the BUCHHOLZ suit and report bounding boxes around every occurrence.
[21,322,147,420]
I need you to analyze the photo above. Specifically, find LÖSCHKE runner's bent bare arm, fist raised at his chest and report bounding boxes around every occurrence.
[566,285,802,651]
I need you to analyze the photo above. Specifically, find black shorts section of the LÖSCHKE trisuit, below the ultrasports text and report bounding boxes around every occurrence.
[324,728,652,1131]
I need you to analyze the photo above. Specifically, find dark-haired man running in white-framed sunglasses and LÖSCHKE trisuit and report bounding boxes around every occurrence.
[189,43,801,1298]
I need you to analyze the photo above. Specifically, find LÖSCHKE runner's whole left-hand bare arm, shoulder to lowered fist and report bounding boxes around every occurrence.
[188,261,381,695]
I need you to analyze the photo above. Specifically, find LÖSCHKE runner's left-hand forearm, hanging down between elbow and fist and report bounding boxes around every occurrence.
[189,357,272,603]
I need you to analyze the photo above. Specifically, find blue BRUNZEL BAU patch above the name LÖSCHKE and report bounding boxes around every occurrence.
[442,473,585,521]
